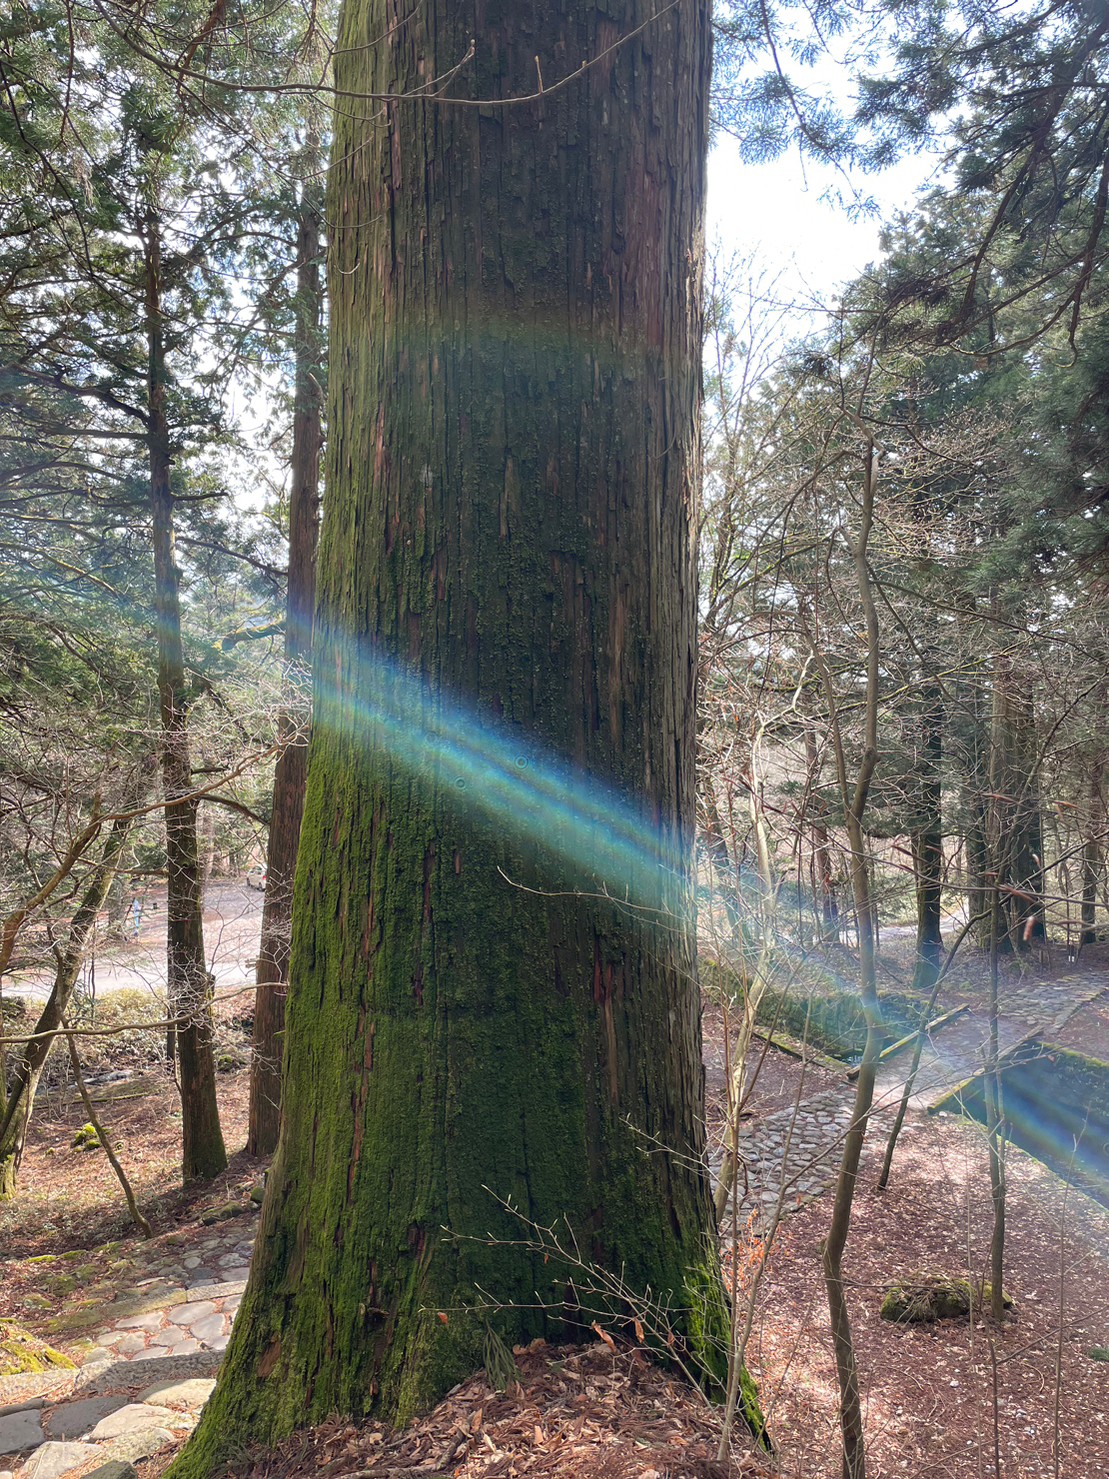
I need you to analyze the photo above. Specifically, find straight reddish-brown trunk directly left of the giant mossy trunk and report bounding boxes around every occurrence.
[247,164,324,1155]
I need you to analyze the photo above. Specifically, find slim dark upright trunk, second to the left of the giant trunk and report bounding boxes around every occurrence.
[145,209,228,1182]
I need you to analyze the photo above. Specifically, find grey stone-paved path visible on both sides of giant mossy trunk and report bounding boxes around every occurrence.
[0,972,1109,1479]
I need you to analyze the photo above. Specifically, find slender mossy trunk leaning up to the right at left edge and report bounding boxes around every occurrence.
[0,821,130,1198]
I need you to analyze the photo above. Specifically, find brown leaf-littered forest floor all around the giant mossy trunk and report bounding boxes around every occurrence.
[0,916,1109,1479]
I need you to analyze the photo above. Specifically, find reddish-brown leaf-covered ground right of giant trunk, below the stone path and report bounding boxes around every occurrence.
[750,1117,1109,1479]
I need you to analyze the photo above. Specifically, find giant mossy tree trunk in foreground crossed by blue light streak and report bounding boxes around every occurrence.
[176,0,748,1475]
